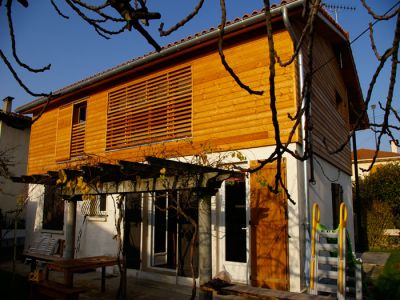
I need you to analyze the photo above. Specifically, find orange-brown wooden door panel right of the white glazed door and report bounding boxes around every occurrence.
[250,162,289,290]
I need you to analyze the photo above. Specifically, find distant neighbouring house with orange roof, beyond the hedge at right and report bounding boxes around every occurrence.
[351,142,400,181]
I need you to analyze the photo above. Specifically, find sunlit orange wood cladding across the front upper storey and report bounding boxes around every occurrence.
[29,31,298,174]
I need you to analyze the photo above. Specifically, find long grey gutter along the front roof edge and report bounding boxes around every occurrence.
[15,0,304,113]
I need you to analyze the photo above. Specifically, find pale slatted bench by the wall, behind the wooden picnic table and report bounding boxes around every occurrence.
[23,236,64,271]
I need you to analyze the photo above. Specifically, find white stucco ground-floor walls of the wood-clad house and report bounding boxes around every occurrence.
[23,144,354,292]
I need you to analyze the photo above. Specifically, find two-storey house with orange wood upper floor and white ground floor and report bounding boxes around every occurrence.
[14,0,363,291]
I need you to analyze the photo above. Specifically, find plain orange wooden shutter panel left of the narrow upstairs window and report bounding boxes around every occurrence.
[56,105,72,161]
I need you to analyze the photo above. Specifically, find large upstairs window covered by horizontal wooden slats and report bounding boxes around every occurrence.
[106,66,192,150]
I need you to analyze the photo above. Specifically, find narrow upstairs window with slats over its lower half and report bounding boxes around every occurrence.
[71,101,86,157]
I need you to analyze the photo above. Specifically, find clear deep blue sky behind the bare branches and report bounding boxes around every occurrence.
[0,0,400,151]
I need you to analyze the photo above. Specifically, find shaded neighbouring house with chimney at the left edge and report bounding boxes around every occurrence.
[0,97,32,247]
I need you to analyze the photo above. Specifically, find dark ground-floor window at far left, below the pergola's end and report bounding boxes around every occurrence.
[42,186,64,230]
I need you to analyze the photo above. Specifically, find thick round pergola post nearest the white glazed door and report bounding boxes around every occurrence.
[198,193,212,300]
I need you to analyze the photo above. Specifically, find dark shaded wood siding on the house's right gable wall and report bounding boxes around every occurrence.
[311,36,351,174]
